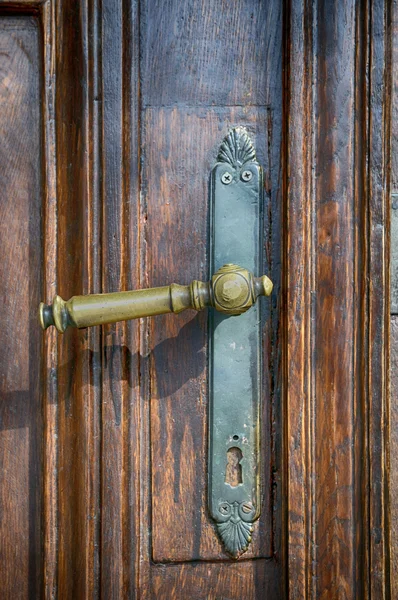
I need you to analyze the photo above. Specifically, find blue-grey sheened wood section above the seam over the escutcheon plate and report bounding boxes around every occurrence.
[142,0,282,106]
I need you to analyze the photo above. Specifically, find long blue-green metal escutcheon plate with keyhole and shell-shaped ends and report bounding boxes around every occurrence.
[209,127,263,558]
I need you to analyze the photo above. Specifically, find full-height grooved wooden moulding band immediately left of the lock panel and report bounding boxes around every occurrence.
[99,0,141,598]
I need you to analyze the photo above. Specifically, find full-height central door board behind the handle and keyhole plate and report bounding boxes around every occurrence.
[142,2,282,598]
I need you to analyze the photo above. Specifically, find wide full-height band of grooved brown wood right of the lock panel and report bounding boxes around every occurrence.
[283,2,390,598]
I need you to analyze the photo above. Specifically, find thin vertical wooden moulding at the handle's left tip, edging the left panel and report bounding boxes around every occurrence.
[41,3,58,599]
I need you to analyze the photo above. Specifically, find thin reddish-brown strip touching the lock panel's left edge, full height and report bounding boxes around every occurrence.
[123,0,142,598]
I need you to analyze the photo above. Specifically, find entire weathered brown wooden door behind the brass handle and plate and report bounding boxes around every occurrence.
[0,0,397,600]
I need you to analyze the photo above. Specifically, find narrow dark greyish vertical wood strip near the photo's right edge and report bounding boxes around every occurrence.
[368,2,392,599]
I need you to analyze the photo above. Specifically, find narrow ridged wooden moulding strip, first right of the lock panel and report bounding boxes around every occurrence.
[282,2,314,600]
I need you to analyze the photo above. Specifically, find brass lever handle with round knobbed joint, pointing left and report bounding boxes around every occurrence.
[39,264,272,333]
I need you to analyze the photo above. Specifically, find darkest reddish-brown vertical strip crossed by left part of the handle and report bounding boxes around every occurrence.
[54,0,101,598]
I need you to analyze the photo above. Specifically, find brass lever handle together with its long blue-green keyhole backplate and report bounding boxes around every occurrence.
[39,127,272,558]
